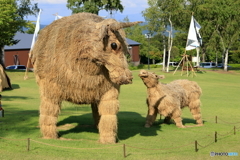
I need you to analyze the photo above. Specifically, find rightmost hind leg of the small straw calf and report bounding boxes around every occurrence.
[189,99,203,126]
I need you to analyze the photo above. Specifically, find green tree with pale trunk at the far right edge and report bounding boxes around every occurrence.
[197,0,240,71]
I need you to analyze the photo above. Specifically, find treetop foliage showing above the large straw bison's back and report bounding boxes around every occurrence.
[67,0,123,15]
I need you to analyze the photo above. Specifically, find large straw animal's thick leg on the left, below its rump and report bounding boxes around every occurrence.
[39,96,60,139]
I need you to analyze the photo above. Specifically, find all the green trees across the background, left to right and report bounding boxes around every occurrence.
[0,0,240,70]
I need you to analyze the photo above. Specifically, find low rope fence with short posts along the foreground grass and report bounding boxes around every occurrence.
[0,116,240,157]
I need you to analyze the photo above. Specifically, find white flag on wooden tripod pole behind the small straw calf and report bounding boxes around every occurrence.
[186,16,202,50]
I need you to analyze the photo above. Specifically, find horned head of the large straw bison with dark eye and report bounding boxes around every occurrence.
[92,19,140,85]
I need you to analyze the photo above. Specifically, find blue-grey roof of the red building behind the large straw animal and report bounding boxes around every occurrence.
[4,32,140,50]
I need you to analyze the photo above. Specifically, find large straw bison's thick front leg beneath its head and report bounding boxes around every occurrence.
[98,87,119,143]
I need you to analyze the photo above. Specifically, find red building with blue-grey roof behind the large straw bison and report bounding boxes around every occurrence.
[4,32,140,68]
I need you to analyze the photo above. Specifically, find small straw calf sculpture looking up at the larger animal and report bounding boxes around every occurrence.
[139,70,203,128]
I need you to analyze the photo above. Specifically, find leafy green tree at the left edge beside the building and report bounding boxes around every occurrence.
[0,0,38,67]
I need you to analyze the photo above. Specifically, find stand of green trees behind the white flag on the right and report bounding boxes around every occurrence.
[142,0,240,71]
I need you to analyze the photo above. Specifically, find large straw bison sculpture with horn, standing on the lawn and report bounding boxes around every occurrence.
[30,13,140,143]
